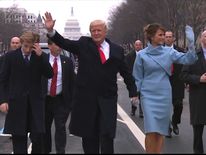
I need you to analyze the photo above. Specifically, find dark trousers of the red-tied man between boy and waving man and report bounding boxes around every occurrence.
[45,95,70,154]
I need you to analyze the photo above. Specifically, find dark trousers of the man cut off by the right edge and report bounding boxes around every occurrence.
[193,125,204,154]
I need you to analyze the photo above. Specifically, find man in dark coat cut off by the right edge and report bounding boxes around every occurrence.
[181,31,206,154]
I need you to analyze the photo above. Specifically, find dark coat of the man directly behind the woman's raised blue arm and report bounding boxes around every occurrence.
[170,45,185,100]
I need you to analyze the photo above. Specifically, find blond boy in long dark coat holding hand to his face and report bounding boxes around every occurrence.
[0,32,53,154]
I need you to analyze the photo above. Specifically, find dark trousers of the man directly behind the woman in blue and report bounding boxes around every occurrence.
[172,99,183,124]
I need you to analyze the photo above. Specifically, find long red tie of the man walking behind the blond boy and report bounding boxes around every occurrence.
[50,58,58,96]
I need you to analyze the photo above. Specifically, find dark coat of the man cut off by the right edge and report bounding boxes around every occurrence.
[181,49,206,125]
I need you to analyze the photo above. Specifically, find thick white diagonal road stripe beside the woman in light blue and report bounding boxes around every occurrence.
[117,104,145,149]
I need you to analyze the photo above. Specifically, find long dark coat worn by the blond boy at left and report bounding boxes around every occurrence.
[0,48,53,135]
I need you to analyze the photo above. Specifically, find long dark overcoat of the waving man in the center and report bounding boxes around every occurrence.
[51,33,137,137]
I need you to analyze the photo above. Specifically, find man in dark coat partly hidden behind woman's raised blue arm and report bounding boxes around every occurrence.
[165,31,185,138]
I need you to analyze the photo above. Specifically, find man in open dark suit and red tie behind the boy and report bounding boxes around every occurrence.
[43,39,75,154]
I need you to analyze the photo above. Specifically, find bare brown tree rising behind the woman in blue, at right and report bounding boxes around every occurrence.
[108,0,206,46]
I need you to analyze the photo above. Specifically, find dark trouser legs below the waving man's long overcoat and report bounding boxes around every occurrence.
[82,136,114,154]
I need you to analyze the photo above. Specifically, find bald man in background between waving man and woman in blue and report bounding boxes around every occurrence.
[125,40,143,118]
